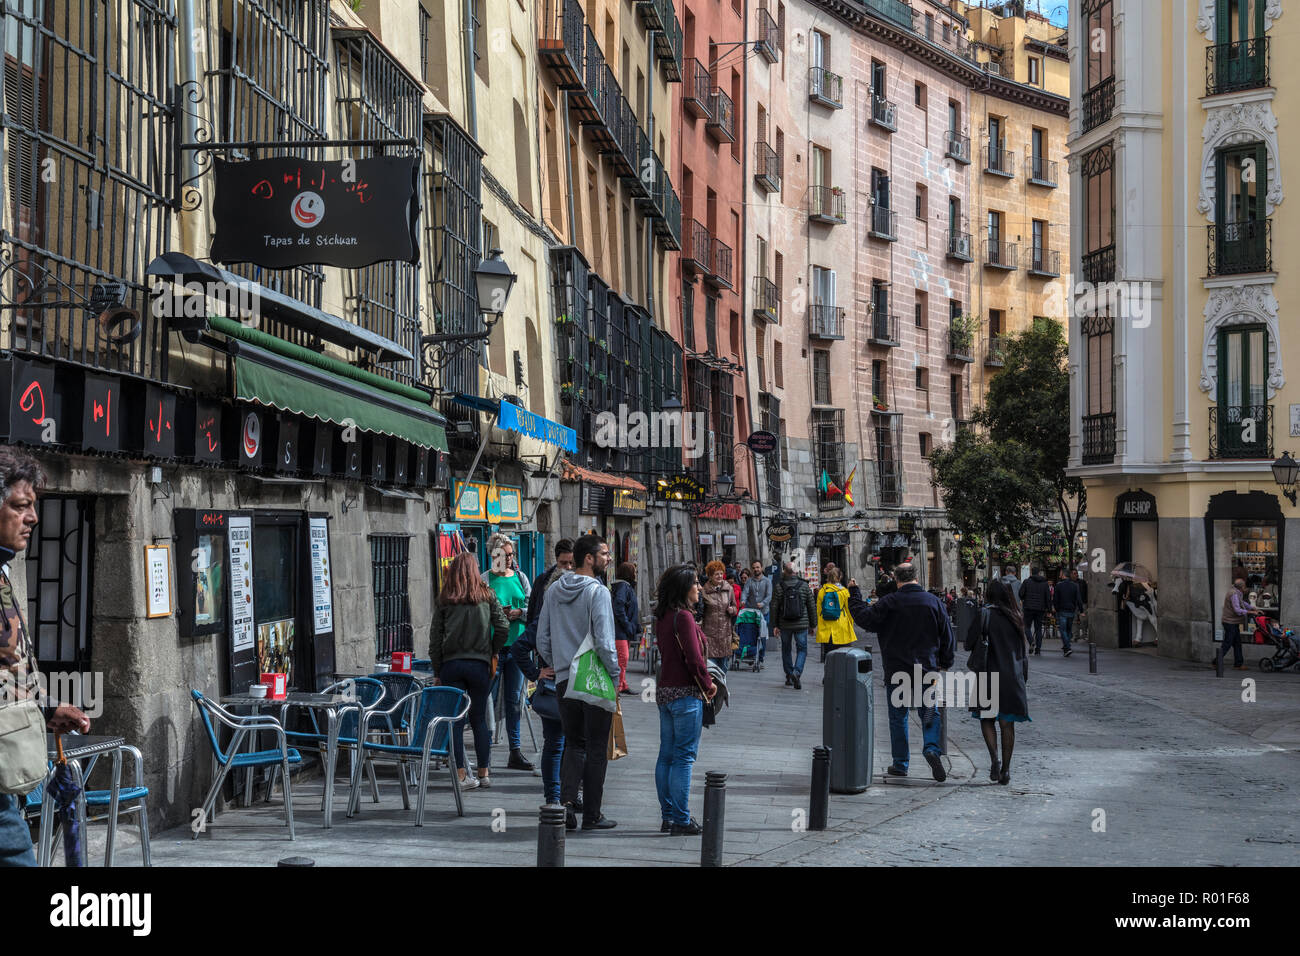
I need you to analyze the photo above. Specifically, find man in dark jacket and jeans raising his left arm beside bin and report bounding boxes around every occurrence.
[849,564,957,783]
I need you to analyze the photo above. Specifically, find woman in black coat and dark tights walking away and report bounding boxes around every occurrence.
[966,579,1030,784]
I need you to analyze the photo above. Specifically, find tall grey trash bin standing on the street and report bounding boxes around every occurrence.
[822,648,875,793]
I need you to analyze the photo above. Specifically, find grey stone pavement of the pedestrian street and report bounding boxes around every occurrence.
[122,641,1300,866]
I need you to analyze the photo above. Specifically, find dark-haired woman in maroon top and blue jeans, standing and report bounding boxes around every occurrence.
[654,566,718,836]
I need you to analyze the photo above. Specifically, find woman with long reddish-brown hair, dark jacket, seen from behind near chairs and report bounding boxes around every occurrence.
[429,551,510,790]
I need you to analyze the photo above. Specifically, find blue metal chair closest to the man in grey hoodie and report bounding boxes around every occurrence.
[347,687,469,826]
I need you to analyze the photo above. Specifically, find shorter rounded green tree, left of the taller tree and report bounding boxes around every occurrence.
[930,429,1053,574]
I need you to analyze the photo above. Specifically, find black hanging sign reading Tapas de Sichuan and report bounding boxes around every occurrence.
[211,156,419,269]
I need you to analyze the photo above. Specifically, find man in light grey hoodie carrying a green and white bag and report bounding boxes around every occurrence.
[537,535,619,830]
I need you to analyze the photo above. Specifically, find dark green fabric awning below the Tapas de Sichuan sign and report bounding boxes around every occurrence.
[231,341,447,451]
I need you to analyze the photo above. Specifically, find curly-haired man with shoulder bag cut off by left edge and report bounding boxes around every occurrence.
[0,446,90,866]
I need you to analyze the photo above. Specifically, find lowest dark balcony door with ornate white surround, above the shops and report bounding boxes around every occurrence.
[1217,326,1269,458]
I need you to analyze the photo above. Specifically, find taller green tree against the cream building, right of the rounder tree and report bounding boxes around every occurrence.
[975,317,1087,564]
